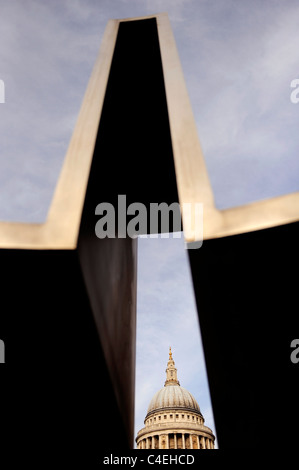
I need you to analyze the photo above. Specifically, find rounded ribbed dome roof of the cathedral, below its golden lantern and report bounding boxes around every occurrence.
[147,385,200,414]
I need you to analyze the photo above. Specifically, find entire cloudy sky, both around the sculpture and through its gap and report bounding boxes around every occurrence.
[0,0,299,448]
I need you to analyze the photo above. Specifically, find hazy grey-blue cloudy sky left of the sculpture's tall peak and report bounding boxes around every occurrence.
[0,1,106,222]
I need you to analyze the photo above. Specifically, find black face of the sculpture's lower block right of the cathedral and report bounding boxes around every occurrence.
[189,223,299,449]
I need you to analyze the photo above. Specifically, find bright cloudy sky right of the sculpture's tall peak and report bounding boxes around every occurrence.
[174,0,299,208]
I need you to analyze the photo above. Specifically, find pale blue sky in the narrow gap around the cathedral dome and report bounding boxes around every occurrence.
[135,232,217,446]
